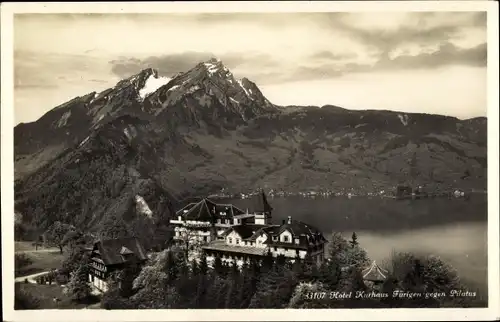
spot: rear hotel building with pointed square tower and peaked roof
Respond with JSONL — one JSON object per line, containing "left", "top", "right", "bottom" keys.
{"left": 170, "top": 192, "right": 272, "bottom": 244}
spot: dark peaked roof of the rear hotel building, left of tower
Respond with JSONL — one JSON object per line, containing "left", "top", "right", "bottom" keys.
{"left": 177, "top": 198, "right": 244, "bottom": 222}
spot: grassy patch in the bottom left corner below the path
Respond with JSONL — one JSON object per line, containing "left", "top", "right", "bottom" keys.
{"left": 16, "top": 283, "right": 100, "bottom": 310}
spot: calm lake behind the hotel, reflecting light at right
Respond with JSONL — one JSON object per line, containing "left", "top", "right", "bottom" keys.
{"left": 224, "top": 194, "right": 488, "bottom": 292}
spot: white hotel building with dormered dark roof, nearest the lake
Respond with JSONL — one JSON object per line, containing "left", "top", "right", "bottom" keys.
{"left": 202, "top": 217, "right": 327, "bottom": 265}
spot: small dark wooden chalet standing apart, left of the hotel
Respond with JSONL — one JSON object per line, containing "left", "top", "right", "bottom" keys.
{"left": 89, "top": 237, "right": 147, "bottom": 292}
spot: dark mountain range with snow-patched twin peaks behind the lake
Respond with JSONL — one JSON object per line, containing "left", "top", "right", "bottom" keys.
{"left": 14, "top": 59, "right": 486, "bottom": 230}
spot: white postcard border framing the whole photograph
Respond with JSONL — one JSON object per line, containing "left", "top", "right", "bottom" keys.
{"left": 1, "top": 1, "right": 500, "bottom": 321}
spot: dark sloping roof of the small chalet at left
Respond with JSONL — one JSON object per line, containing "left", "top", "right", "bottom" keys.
{"left": 93, "top": 237, "right": 147, "bottom": 265}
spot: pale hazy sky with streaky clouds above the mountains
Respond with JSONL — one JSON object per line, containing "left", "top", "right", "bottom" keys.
{"left": 14, "top": 12, "right": 487, "bottom": 123}
